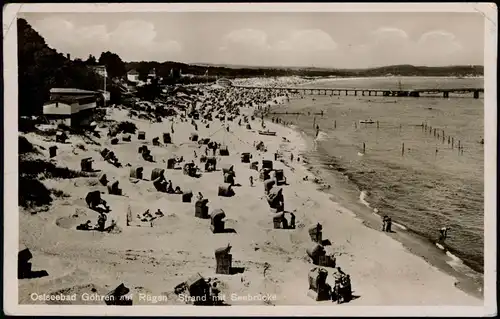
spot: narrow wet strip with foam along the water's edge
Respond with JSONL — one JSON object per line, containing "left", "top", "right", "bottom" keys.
{"left": 266, "top": 99, "right": 484, "bottom": 300}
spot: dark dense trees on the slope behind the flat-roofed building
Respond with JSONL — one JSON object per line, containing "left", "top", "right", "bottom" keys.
{"left": 17, "top": 19, "right": 127, "bottom": 115}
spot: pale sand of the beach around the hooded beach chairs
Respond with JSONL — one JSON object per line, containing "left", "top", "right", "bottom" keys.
{"left": 19, "top": 84, "right": 482, "bottom": 306}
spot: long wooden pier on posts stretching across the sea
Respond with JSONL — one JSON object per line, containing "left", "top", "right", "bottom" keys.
{"left": 234, "top": 85, "right": 484, "bottom": 99}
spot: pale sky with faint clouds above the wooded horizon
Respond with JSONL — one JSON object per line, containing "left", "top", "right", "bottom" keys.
{"left": 19, "top": 12, "right": 484, "bottom": 68}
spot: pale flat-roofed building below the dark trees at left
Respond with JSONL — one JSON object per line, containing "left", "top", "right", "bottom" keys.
{"left": 43, "top": 88, "right": 99, "bottom": 127}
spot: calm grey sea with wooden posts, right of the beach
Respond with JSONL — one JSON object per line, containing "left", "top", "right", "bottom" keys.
{"left": 273, "top": 77, "right": 484, "bottom": 282}
